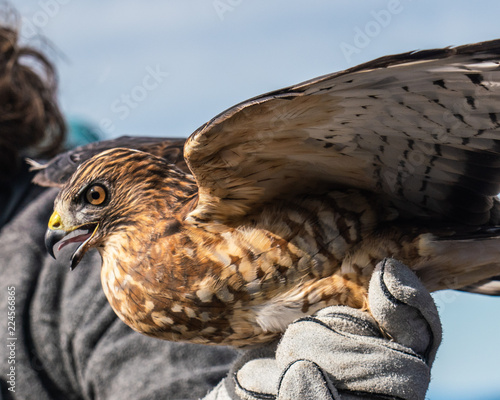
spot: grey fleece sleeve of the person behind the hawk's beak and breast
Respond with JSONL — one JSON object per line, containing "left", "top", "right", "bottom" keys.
{"left": 0, "top": 190, "right": 235, "bottom": 400}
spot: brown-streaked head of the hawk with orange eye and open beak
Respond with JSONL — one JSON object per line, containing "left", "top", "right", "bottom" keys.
{"left": 45, "top": 148, "right": 196, "bottom": 269}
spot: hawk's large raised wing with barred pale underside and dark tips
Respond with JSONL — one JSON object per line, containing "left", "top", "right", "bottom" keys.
{"left": 184, "top": 40, "right": 500, "bottom": 224}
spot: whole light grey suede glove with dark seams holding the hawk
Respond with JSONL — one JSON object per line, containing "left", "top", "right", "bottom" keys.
{"left": 205, "top": 259, "right": 441, "bottom": 400}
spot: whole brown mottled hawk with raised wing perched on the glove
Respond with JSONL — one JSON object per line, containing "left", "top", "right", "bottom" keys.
{"left": 37, "top": 40, "right": 500, "bottom": 346}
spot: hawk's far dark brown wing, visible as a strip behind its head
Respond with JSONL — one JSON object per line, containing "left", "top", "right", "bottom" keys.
{"left": 28, "top": 136, "right": 189, "bottom": 187}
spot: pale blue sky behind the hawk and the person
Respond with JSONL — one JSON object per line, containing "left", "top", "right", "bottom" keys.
{"left": 14, "top": 0, "right": 500, "bottom": 400}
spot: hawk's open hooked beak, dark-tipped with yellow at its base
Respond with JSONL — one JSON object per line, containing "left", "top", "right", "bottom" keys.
{"left": 45, "top": 211, "right": 99, "bottom": 270}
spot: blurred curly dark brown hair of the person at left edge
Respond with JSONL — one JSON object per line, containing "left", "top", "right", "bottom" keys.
{"left": 0, "top": 22, "right": 66, "bottom": 180}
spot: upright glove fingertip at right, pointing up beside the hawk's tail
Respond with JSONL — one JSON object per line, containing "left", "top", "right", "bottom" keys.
{"left": 368, "top": 259, "right": 442, "bottom": 366}
